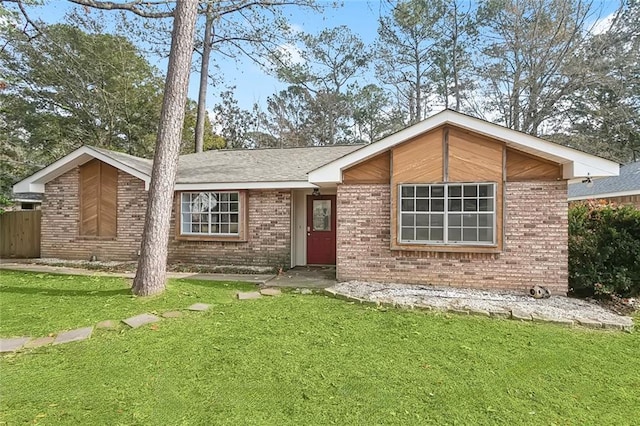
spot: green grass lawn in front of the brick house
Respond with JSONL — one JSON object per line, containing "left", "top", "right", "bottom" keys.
{"left": 0, "top": 273, "right": 640, "bottom": 425}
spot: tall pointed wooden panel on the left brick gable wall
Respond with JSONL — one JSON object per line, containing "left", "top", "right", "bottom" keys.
{"left": 79, "top": 160, "right": 118, "bottom": 238}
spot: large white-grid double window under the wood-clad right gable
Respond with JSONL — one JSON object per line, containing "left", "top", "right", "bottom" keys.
{"left": 398, "top": 183, "right": 496, "bottom": 245}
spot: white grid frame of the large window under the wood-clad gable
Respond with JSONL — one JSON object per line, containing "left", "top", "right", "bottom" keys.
{"left": 397, "top": 182, "right": 497, "bottom": 246}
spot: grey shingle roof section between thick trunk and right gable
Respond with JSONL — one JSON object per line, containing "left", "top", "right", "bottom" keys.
{"left": 176, "top": 145, "right": 362, "bottom": 190}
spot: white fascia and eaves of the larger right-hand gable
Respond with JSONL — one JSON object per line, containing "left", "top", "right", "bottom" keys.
{"left": 309, "top": 110, "right": 619, "bottom": 185}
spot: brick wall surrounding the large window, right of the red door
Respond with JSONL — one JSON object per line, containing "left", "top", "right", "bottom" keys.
{"left": 336, "top": 182, "right": 568, "bottom": 294}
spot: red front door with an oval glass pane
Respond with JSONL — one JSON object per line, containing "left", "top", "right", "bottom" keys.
{"left": 307, "top": 195, "right": 336, "bottom": 265}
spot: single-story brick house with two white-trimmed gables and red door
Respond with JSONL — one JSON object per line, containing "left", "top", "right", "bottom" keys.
{"left": 14, "top": 110, "right": 618, "bottom": 294}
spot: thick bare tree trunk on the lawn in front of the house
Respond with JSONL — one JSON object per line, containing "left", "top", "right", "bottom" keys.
{"left": 133, "top": 0, "right": 198, "bottom": 296}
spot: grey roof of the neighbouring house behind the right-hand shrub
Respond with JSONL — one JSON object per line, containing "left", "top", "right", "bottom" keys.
{"left": 569, "top": 161, "right": 640, "bottom": 201}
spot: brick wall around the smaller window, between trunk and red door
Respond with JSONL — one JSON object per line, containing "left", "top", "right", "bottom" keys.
{"left": 169, "top": 190, "right": 291, "bottom": 268}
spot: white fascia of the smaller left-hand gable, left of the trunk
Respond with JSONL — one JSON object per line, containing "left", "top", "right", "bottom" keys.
{"left": 13, "top": 146, "right": 151, "bottom": 194}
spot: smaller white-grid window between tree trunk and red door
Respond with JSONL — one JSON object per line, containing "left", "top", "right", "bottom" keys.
{"left": 180, "top": 192, "right": 240, "bottom": 236}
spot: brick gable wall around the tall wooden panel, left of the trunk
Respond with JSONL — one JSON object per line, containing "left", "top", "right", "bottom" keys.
{"left": 40, "top": 168, "right": 147, "bottom": 261}
